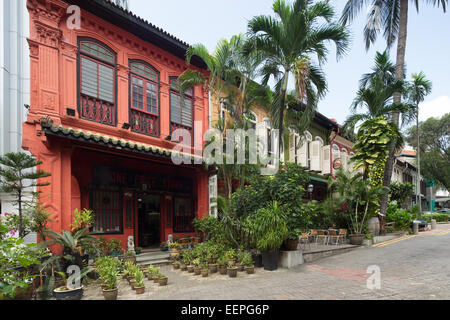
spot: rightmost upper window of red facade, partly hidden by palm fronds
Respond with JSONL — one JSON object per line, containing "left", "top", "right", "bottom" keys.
{"left": 169, "top": 77, "right": 194, "bottom": 145}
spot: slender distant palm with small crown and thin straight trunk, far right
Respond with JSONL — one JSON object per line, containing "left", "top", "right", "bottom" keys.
{"left": 408, "top": 72, "right": 432, "bottom": 215}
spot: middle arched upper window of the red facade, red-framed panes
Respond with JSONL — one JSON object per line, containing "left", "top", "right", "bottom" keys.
{"left": 130, "top": 60, "right": 159, "bottom": 136}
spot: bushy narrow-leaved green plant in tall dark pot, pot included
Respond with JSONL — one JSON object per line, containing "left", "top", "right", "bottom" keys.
{"left": 250, "top": 201, "right": 288, "bottom": 271}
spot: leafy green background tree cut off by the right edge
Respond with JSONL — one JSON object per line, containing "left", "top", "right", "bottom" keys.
{"left": 407, "top": 113, "right": 450, "bottom": 190}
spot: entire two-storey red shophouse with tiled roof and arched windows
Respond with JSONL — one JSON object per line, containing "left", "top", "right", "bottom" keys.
{"left": 23, "top": 0, "right": 214, "bottom": 248}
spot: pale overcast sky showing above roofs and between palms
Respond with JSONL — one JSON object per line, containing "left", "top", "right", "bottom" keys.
{"left": 130, "top": 0, "right": 450, "bottom": 124}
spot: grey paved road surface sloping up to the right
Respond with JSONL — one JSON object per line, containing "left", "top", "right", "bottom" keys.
{"left": 84, "top": 225, "right": 450, "bottom": 300}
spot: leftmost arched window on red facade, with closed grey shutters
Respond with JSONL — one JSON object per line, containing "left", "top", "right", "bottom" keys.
{"left": 78, "top": 38, "right": 116, "bottom": 125}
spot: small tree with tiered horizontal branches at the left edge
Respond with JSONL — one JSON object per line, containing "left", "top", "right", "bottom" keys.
{"left": 0, "top": 152, "right": 51, "bottom": 238}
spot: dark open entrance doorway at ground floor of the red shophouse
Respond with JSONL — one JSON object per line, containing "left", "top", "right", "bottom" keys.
{"left": 138, "top": 194, "right": 161, "bottom": 248}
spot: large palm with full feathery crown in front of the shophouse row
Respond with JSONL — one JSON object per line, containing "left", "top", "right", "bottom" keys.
{"left": 248, "top": 0, "right": 349, "bottom": 159}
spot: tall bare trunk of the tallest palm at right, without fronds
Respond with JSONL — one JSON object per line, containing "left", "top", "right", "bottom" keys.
{"left": 380, "top": 0, "right": 408, "bottom": 231}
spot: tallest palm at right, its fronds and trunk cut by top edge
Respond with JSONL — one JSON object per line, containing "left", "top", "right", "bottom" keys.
{"left": 341, "top": 0, "right": 448, "bottom": 230}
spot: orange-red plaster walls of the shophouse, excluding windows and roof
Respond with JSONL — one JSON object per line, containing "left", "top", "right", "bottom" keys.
{"left": 23, "top": 0, "right": 209, "bottom": 250}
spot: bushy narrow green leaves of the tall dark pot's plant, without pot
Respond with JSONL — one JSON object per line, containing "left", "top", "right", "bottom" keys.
{"left": 249, "top": 201, "right": 289, "bottom": 251}
